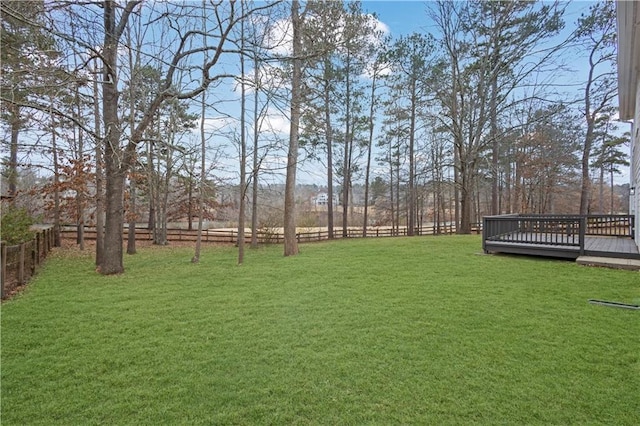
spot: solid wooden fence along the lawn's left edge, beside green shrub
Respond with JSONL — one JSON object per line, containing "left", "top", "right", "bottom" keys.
{"left": 0, "top": 226, "right": 55, "bottom": 299}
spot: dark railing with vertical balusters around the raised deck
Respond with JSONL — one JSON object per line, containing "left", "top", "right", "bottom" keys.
{"left": 482, "top": 214, "right": 634, "bottom": 252}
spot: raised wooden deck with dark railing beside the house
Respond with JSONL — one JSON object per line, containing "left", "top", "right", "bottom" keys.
{"left": 483, "top": 215, "right": 640, "bottom": 259}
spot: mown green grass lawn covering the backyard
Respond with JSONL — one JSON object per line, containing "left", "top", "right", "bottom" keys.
{"left": 1, "top": 236, "right": 640, "bottom": 425}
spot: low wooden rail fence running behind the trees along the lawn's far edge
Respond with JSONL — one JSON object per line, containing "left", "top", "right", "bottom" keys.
{"left": 60, "top": 224, "right": 455, "bottom": 244}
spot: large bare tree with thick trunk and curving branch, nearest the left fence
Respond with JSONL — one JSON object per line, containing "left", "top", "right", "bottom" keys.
{"left": 60, "top": 1, "right": 278, "bottom": 274}
